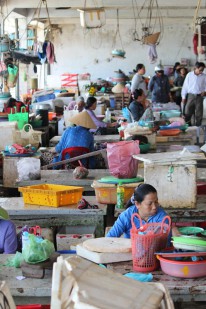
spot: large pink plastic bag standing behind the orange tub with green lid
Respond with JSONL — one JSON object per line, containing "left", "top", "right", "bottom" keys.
{"left": 107, "top": 140, "right": 140, "bottom": 178}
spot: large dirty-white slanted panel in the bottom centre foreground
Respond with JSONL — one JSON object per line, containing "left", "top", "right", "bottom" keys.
{"left": 51, "top": 256, "right": 166, "bottom": 309}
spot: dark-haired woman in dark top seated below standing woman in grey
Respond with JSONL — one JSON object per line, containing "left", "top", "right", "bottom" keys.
{"left": 129, "top": 89, "right": 145, "bottom": 121}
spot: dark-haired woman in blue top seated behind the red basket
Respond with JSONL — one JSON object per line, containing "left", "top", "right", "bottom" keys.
{"left": 107, "top": 184, "right": 180, "bottom": 238}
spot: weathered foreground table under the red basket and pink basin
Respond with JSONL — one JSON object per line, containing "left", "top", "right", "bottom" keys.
{"left": 0, "top": 254, "right": 206, "bottom": 308}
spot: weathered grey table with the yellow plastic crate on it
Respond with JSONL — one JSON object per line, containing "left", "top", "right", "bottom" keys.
{"left": 0, "top": 196, "right": 107, "bottom": 237}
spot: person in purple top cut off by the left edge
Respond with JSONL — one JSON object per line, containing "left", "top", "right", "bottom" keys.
{"left": 0, "top": 207, "right": 17, "bottom": 253}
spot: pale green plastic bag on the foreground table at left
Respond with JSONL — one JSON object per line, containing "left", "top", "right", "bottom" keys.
{"left": 22, "top": 234, "right": 55, "bottom": 264}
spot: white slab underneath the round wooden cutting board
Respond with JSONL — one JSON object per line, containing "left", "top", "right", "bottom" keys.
{"left": 76, "top": 244, "right": 132, "bottom": 264}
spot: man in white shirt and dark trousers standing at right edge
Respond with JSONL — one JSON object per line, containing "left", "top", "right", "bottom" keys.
{"left": 181, "top": 62, "right": 206, "bottom": 127}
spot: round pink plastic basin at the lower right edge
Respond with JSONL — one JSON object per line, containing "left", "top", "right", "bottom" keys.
{"left": 157, "top": 252, "right": 206, "bottom": 278}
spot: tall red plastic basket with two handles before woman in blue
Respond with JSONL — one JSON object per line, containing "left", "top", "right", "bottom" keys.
{"left": 131, "top": 214, "right": 171, "bottom": 272}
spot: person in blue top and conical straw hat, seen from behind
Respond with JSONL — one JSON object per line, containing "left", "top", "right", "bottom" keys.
{"left": 53, "top": 111, "right": 96, "bottom": 168}
